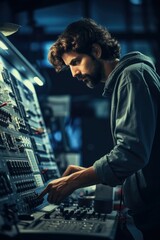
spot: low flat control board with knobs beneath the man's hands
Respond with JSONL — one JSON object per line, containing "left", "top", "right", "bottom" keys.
{"left": 20, "top": 204, "right": 117, "bottom": 240}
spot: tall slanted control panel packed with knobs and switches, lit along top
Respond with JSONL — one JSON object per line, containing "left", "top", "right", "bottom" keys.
{"left": 0, "top": 31, "right": 60, "bottom": 237}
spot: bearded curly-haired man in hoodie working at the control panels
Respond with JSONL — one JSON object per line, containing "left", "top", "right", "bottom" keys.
{"left": 40, "top": 19, "right": 160, "bottom": 239}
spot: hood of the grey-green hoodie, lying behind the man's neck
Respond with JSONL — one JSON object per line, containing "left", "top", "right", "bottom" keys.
{"left": 102, "top": 51, "right": 160, "bottom": 97}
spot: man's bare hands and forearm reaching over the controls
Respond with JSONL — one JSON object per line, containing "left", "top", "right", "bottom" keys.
{"left": 39, "top": 165, "right": 100, "bottom": 204}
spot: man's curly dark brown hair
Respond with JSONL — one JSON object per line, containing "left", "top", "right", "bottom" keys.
{"left": 48, "top": 18, "right": 120, "bottom": 72}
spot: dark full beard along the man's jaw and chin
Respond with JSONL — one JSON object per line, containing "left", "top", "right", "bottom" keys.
{"left": 78, "top": 57, "right": 102, "bottom": 88}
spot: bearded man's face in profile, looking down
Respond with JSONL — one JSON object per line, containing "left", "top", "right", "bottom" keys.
{"left": 62, "top": 52, "right": 102, "bottom": 88}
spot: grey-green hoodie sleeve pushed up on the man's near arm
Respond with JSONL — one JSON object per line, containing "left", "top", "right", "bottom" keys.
{"left": 94, "top": 66, "right": 157, "bottom": 186}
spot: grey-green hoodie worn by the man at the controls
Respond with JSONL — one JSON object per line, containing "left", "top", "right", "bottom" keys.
{"left": 94, "top": 52, "right": 160, "bottom": 229}
